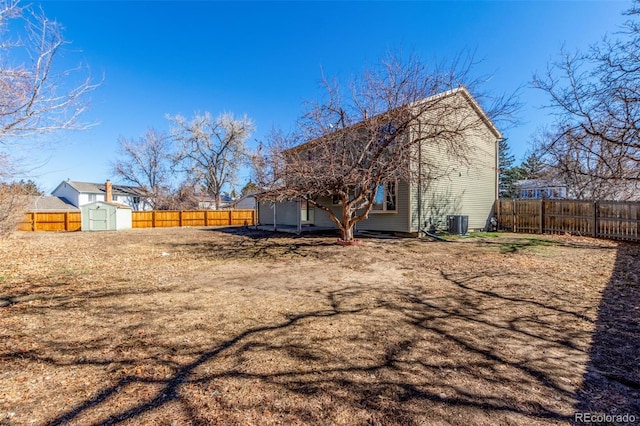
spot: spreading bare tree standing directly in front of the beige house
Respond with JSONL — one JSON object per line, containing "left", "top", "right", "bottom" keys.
{"left": 253, "top": 51, "right": 516, "bottom": 241}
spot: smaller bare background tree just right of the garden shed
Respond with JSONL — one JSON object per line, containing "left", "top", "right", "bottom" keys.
{"left": 113, "top": 129, "right": 172, "bottom": 209}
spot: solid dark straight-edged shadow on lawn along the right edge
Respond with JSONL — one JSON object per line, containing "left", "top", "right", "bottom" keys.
{"left": 575, "top": 243, "right": 640, "bottom": 424}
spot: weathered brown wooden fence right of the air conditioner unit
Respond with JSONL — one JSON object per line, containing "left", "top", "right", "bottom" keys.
{"left": 496, "top": 199, "right": 640, "bottom": 241}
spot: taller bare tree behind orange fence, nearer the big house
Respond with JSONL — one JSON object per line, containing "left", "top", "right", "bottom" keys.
{"left": 167, "top": 112, "right": 254, "bottom": 208}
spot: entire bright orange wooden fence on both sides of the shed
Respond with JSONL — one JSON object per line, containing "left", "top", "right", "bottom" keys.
{"left": 18, "top": 210, "right": 255, "bottom": 231}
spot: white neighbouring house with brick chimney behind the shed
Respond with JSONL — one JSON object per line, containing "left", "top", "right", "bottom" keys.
{"left": 51, "top": 179, "right": 152, "bottom": 210}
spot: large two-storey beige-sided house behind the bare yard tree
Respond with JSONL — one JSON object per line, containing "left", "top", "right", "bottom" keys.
{"left": 258, "top": 88, "right": 502, "bottom": 235}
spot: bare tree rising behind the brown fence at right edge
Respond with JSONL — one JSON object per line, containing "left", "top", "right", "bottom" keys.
{"left": 534, "top": 1, "right": 640, "bottom": 199}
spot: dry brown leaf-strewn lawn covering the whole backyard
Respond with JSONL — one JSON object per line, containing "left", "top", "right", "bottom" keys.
{"left": 0, "top": 228, "right": 640, "bottom": 425}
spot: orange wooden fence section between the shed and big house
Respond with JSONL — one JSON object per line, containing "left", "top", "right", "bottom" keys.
{"left": 131, "top": 210, "right": 255, "bottom": 228}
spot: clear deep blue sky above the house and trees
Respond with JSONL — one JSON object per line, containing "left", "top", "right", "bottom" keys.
{"left": 23, "top": 0, "right": 631, "bottom": 193}
